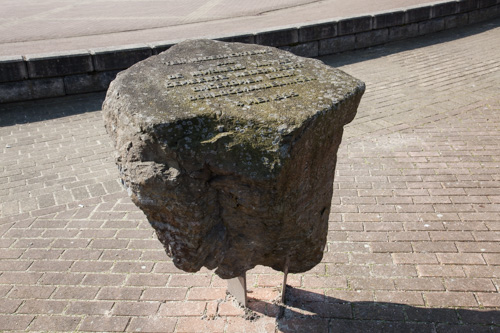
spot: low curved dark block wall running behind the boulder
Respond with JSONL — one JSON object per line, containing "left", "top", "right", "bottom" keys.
{"left": 0, "top": 0, "right": 500, "bottom": 103}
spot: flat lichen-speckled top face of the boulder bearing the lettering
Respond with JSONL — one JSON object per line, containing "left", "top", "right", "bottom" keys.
{"left": 108, "top": 40, "right": 363, "bottom": 127}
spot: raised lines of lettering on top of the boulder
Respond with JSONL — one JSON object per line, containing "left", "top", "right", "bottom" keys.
{"left": 165, "top": 50, "right": 315, "bottom": 107}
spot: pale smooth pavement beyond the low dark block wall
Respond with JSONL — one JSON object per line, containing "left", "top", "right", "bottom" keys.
{"left": 0, "top": 0, "right": 443, "bottom": 56}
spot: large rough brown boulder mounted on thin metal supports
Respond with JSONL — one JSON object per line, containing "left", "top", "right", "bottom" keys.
{"left": 103, "top": 40, "right": 364, "bottom": 278}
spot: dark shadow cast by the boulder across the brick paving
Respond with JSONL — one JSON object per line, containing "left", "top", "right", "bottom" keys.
{"left": 249, "top": 286, "right": 500, "bottom": 333}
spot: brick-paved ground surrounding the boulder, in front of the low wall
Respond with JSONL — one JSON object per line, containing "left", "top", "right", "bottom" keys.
{"left": 0, "top": 20, "right": 500, "bottom": 332}
